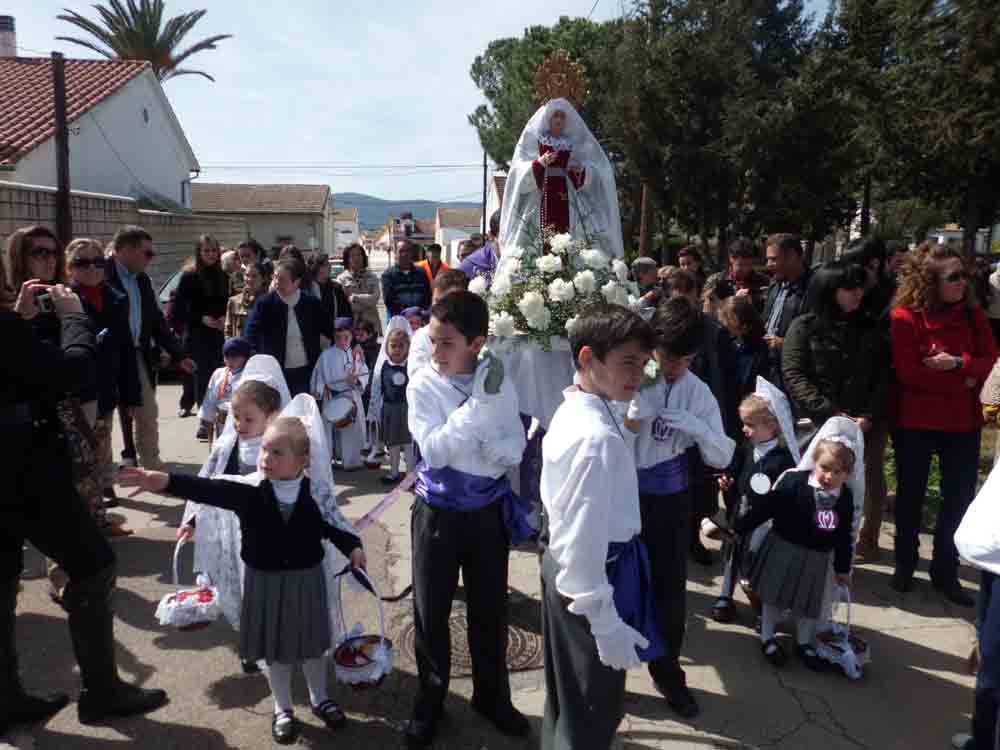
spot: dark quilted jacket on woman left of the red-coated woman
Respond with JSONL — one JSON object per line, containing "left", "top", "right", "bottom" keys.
{"left": 781, "top": 313, "right": 889, "bottom": 426}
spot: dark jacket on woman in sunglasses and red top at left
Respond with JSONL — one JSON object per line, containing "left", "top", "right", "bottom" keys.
{"left": 77, "top": 284, "right": 142, "bottom": 417}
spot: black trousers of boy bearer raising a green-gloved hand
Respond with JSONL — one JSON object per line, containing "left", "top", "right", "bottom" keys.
{"left": 411, "top": 498, "right": 510, "bottom": 724}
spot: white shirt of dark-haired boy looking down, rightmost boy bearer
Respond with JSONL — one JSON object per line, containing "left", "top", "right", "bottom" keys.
{"left": 628, "top": 371, "right": 736, "bottom": 469}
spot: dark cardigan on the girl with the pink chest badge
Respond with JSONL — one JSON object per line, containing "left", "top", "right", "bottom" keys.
{"left": 735, "top": 471, "right": 854, "bottom": 573}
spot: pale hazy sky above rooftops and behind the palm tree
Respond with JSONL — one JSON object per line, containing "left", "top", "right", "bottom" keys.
{"left": 11, "top": 0, "right": 827, "bottom": 200}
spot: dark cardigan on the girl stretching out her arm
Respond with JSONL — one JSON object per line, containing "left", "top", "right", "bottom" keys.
{"left": 167, "top": 474, "right": 361, "bottom": 571}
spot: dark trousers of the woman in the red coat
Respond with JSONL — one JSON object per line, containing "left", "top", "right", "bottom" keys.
{"left": 892, "top": 429, "right": 981, "bottom": 584}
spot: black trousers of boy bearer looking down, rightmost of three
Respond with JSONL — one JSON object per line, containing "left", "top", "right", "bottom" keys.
{"left": 639, "top": 491, "right": 691, "bottom": 687}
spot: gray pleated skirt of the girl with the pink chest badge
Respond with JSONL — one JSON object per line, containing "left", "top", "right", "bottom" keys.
{"left": 750, "top": 530, "right": 832, "bottom": 619}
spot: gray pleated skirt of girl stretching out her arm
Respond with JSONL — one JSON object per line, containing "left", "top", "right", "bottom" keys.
{"left": 240, "top": 564, "right": 330, "bottom": 664}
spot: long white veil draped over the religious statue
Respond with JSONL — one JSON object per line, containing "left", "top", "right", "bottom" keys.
{"left": 499, "top": 99, "right": 625, "bottom": 258}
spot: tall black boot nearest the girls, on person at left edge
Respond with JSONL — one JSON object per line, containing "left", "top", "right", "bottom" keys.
{"left": 63, "top": 565, "right": 167, "bottom": 724}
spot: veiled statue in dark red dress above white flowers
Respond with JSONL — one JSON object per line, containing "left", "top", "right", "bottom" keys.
{"left": 500, "top": 99, "right": 624, "bottom": 258}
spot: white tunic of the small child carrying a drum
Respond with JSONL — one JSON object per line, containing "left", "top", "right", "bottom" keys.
{"left": 311, "top": 346, "right": 368, "bottom": 469}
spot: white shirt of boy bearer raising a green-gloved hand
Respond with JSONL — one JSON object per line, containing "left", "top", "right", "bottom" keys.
{"left": 407, "top": 361, "right": 526, "bottom": 479}
